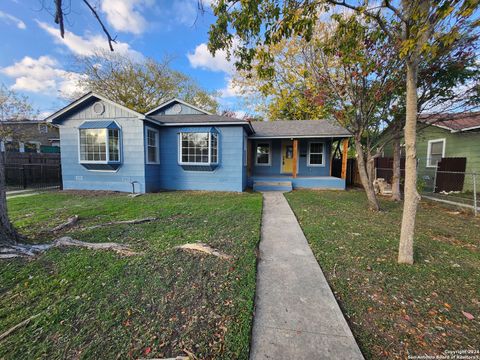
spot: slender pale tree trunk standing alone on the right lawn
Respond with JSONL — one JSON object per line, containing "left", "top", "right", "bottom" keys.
{"left": 398, "top": 60, "right": 420, "bottom": 264}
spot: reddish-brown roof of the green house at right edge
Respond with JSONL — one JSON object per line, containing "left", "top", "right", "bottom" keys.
{"left": 418, "top": 111, "right": 480, "bottom": 132}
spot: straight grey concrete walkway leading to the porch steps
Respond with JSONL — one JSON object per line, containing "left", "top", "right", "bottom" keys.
{"left": 250, "top": 192, "right": 363, "bottom": 360}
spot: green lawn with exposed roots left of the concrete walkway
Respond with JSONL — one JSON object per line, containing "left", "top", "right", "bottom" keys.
{"left": 0, "top": 192, "right": 262, "bottom": 359}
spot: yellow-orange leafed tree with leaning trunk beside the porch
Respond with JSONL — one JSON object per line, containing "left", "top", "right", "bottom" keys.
{"left": 234, "top": 16, "right": 401, "bottom": 210}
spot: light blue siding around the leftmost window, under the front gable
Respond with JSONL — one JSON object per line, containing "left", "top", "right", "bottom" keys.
{"left": 59, "top": 100, "right": 146, "bottom": 192}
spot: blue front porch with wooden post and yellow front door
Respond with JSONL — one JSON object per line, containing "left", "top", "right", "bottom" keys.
{"left": 247, "top": 136, "right": 348, "bottom": 191}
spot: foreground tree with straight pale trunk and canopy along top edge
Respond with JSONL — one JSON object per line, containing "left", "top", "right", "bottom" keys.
{"left": 209, "top": 0, "right": 479, "bottom": 264}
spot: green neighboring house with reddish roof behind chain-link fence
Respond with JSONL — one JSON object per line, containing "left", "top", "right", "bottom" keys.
{"left": 384, "top": 112, "right": 480, "bottom": 190}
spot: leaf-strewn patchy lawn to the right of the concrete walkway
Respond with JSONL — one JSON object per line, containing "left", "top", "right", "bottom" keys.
{"left": 286, "top": 190, "right": 480, "bottom": 359}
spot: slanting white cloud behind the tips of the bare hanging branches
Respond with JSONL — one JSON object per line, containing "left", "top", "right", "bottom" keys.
{"left": 37, "top": 21, "right": 142, "bottom": 58}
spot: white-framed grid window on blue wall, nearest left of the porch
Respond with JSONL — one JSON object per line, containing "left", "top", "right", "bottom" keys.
{"left": 180, "top": 132, "right": 218, "bottom": 165}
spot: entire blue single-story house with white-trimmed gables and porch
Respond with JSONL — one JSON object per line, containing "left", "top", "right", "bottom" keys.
{"left": 46, "top": 93, "right": 351, "bottom": 193}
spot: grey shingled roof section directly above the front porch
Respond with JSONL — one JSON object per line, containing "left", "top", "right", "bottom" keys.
{"left": 250, "top": 120, "right": 352, "bottom": 138}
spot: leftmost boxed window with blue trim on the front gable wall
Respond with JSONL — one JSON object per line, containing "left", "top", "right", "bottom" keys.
{"left": 79, "top": 121, "right": 121, "bottom": 170}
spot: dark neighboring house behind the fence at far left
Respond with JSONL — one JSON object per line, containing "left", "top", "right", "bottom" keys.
{"left": 0, "top": 120, "right": 60, "bottom": 153}
